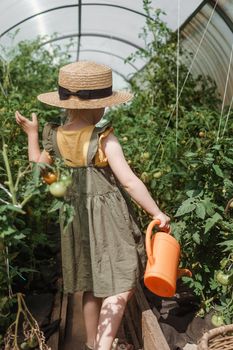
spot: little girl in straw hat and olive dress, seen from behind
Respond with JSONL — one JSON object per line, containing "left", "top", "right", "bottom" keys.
{"left": 16, "top": 61, "right": 169, "bottom": 350}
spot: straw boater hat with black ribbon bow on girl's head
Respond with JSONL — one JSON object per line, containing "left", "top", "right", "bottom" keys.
{"left": 37, "top": 61, "right": 133, "bottom": 109}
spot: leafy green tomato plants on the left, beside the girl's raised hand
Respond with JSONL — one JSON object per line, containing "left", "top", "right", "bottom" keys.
{"left": 0, "top": 38, "right": 72, "bottom": 342}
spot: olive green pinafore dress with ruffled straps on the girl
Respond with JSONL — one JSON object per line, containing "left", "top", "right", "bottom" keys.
{"left": 43, "top": 124, "right": 145, "bottom": 297}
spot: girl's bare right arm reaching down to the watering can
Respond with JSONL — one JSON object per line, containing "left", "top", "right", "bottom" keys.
{"left": 103, "top": 133, "right": 170, "bottom": 227}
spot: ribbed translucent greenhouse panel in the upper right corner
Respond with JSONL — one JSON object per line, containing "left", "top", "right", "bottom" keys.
{"left": 182, "top": 1, "right": 233, "bottom": 104}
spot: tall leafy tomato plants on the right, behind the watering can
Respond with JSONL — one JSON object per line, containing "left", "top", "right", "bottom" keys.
{"left": 108, "top": 2, "right": 233, "bottom": 323}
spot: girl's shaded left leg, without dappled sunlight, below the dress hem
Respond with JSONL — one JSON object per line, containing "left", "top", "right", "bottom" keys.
{"left": 83, "top": 292, "right": 102, "bottom": 348}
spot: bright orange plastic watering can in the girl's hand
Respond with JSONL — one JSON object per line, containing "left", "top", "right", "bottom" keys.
{"left": 144, "top": 220, "right": 192, "bottom": 297}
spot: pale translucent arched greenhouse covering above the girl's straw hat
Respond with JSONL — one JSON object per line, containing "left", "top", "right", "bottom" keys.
{"left": 0, "top": 0, "right": 202, "bottom": 87}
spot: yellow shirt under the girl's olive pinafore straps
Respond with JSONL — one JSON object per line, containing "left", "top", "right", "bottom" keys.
{"left": 57, "top": 125, "right": 113, "bottom": 167}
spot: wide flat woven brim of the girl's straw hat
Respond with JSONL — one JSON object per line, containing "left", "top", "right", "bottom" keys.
{"left": 37, "top": 91, "right": 133, "bottom": 109}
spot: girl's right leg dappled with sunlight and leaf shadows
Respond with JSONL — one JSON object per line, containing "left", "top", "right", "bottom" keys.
{"left": 95, "top": 290, "right": 133, "bottom": 350}
